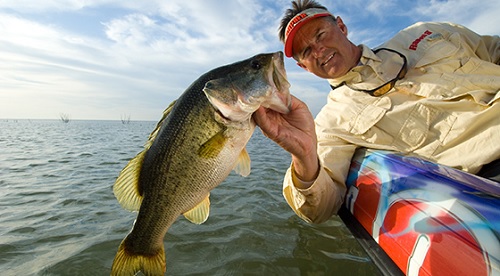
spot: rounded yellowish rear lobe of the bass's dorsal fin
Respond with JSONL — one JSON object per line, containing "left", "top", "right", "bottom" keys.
{"left": 113, "top": 150, "right": 146, "bottom": 211}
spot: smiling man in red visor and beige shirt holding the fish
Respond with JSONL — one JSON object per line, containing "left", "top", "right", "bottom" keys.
{"left": 254, "top": 0, "right": 500, "bottom": 223}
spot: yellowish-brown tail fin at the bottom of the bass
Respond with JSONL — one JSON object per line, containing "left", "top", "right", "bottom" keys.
{"left": 111, "top": 240, "right": 166, "bottom": 276}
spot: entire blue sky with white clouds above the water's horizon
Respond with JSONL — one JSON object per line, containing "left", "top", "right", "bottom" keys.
{"left": 0, "top": 0, "right": 500, "bottom": 121}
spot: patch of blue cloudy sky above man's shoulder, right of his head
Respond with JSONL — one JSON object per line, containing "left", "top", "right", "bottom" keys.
{"left": 326, "top": 0, "right": 500, "bottom": 47}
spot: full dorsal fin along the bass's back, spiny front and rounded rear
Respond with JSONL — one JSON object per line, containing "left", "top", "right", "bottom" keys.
{"left": 113, "top": 101, "right": 176, "bottom": 211}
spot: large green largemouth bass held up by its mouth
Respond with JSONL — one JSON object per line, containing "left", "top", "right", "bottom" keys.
{"left": 111, "top": 52, "right": 291, "bottom": 276}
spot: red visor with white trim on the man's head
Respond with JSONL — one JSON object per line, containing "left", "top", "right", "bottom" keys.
{"left": 285, "top": 8, "right": 333, "bottom": 57}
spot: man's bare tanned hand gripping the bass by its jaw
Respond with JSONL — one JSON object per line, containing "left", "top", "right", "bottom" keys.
{"left": 253, "top": 96, "right": 319, "bottom": 181}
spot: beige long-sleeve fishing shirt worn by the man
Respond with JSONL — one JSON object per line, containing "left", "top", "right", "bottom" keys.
{"left": 283, "top": 23, "right": 500, "bottom": 223}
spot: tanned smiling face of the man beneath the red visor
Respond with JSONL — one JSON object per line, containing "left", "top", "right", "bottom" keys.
{"left": 293, "top": 17, "right": 360, "bottom": 79}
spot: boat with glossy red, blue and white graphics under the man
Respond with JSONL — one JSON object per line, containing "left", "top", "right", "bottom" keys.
{"left": 339, "top": 149, "right": 500, "bottom": 276}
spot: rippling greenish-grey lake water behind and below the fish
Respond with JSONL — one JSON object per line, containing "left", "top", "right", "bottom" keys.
{"left": 0, "top": 120, "right": 378, "bottom": 275}
